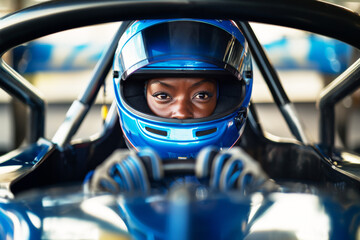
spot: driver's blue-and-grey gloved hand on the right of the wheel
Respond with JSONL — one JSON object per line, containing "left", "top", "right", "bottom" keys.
{"left": 195, "top": 147, "right": 268, "bottom": 194}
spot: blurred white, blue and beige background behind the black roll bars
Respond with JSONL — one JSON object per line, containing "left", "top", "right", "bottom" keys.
{"left": 0, "top": 0, "right": 360, "bottom": 152}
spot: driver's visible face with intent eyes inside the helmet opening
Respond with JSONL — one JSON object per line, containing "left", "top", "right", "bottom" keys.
{"left": 146, "top": 78, "right": 217, "bottom": 119}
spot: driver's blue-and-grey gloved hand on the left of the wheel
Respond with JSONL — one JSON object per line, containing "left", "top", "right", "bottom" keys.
{"left": 85, "top": 149, "right": 163, "bottom": 193}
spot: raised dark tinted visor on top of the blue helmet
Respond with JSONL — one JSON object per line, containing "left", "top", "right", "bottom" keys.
{"left": 119, "top": 21, "right": 244, "bottom": 79}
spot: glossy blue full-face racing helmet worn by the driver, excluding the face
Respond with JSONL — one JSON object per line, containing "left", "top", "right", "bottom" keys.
{"left": 113, "top": 19, "right": 253, "bottom": 160}
